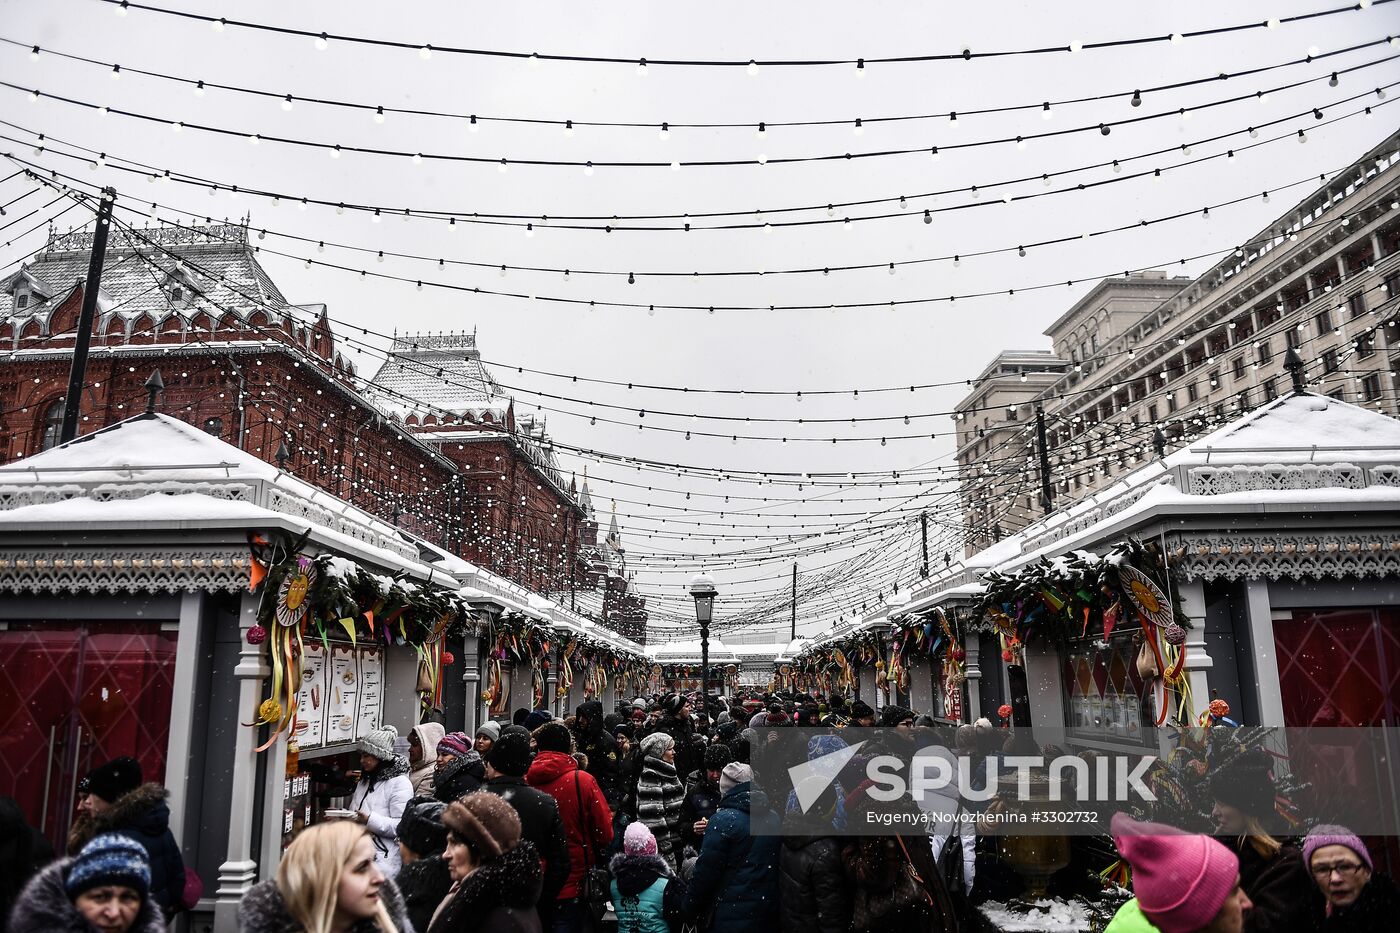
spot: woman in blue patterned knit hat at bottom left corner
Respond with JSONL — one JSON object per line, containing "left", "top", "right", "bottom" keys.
{"left": 6, "top": 834, "right": 165, "bottom": 933}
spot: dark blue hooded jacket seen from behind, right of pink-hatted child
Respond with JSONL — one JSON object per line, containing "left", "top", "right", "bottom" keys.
{"left": 686, "top": 782, "right": 780, "bottom": 933}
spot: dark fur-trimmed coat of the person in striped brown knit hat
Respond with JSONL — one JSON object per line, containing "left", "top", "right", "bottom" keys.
{"left": 426, "top": 839, "right": 540, "bottom": 933}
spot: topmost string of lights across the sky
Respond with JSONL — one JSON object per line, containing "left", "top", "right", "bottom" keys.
{"left": 101, "top": 0, "right": 1392, "bottom": 69}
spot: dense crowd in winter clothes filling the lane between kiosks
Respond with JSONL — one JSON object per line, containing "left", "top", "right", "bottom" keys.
{"left": 0, "top": 693, "right": 1400, "bottom": 933}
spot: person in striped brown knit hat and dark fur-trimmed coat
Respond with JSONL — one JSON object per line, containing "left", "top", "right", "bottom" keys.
{"left": 427, "top": 790, "right": 543, "bottom": 933}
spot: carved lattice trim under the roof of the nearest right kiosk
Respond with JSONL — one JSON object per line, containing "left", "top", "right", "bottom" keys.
{"left": 1172, "top": 531, "right": 1400, "bottom": 580}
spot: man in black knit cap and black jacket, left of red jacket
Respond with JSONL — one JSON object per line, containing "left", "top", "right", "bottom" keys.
{"left": 482, "top": 726, "right": 570, "bottom": 930}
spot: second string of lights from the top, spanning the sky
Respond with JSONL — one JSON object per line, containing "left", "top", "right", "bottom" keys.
{"left": 8, "top": 35, "right": 1392, "bottom": 141}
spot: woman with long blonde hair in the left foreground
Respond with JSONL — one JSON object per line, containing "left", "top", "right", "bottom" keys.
{"left": 238, "top": 821, "right": 410, "bottom": 933}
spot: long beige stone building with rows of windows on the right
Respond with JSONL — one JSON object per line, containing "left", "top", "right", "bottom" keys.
{"left": 955, "top": 133, "right": 1400, "bottom": 553}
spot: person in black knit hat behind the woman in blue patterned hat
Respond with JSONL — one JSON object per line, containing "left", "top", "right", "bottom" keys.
{"left": 67, "top": 758, "right": 185, "bottom": 919}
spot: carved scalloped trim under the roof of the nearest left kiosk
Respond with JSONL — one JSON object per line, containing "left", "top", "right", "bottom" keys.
{"left": 0, "top": 548, "right": 248, "bottom": 593}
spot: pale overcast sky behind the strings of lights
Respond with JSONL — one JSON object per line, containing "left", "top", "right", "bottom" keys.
{"left": 8, "top": 0, "right": 1400, "bottom": 632}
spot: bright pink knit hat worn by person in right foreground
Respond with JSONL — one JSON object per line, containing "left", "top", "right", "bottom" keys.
{"left": 1112, "top": 813, "right": 1239, "bottom": 933}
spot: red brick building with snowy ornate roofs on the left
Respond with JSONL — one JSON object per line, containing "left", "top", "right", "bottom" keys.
{"left": 0, "top": 218, "right": 645, "bottom": 624}
